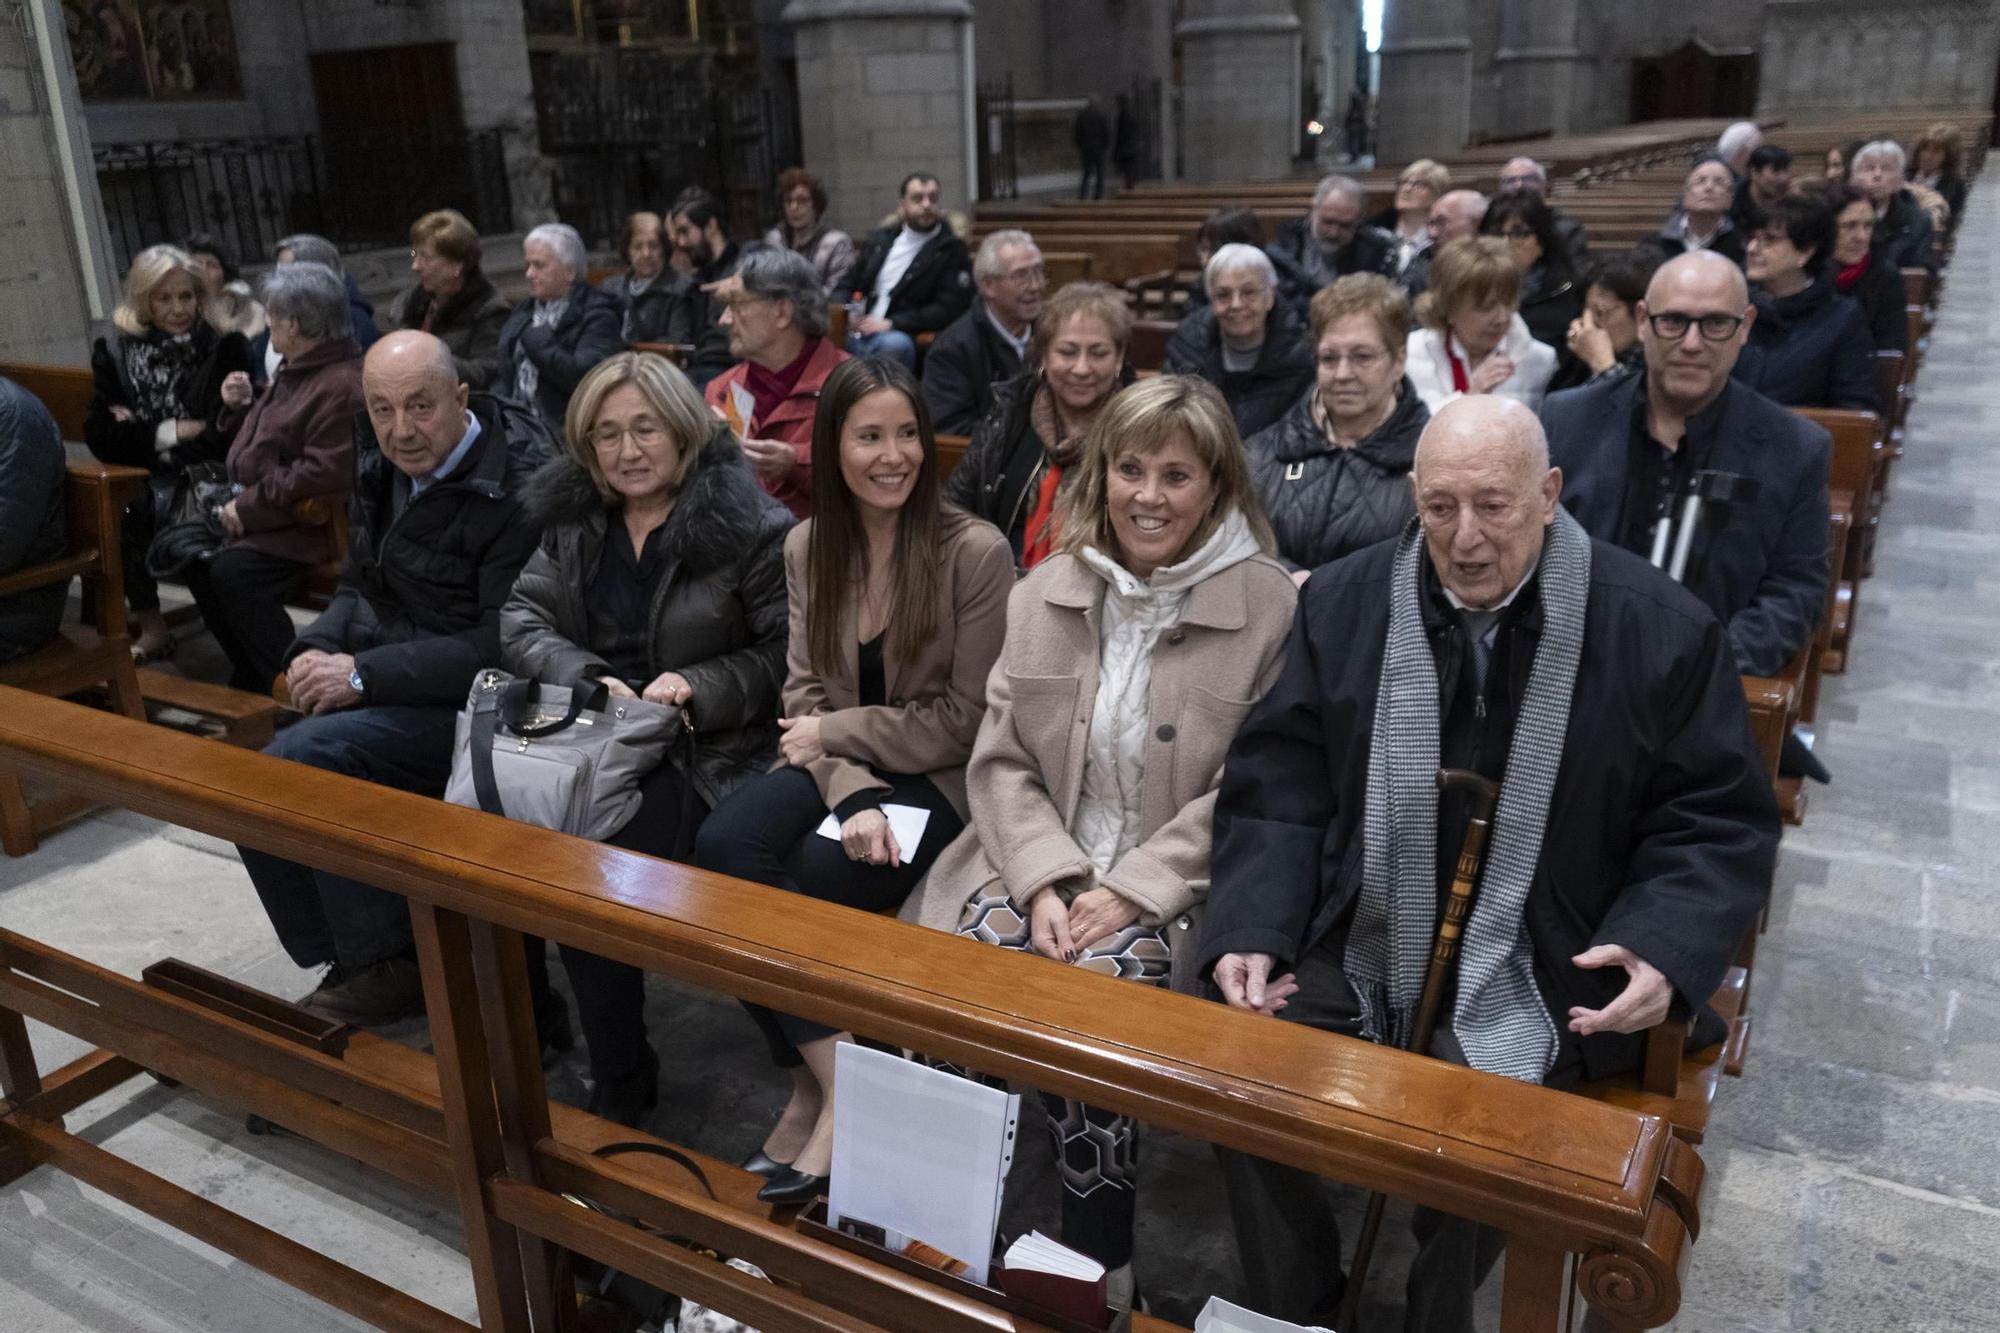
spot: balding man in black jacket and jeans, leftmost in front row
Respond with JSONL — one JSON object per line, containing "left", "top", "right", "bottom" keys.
{"left": 238, "top": 332, "right": 554, "bottom": 1025}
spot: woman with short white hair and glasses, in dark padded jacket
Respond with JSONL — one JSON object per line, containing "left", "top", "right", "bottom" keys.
{"left": 1164, "top": 244, "right": 1312, "bottom": 438}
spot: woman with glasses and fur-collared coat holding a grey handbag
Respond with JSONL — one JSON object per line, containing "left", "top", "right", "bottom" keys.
{"left": 500, "top": 352, "right": 792, "bottom": 1127}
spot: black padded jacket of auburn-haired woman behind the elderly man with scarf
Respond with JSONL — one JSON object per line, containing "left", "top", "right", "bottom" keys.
{"left": 1248, "top": 380, "right": 1430, "bottom": 570}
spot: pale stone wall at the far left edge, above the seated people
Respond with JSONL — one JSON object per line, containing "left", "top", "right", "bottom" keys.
{"left": 0, "top": 13, "right": 90, "bottom": 366}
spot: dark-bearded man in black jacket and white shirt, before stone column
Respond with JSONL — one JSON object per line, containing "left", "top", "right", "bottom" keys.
{"left": 848, "top": 172, "right": 972, "bottom": 368}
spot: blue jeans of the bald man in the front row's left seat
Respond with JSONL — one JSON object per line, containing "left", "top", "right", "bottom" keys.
{"left": 236, "top": 705, "right": 458, "bottom": 971}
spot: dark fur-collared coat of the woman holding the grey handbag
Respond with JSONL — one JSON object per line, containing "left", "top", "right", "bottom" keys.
{"left": 500, "top": 430, "right": 792, "bottom": 807}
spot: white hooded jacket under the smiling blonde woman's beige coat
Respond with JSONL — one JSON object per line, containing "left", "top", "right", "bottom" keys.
{"left": 1070, "top": 510, "right": 1258, "bottom": 875}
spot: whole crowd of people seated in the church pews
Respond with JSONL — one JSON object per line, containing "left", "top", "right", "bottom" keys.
{"left": 0, "top": 119, "right": 1964, "bottom": 1329}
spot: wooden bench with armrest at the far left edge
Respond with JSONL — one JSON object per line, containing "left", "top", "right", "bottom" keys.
{"left": 0, "top": 462, "right": 146, "bottom": 857}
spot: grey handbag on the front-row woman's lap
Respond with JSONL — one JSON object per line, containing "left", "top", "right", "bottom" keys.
{"left": 444, "top": 671, "right": 692, "bottom": 843}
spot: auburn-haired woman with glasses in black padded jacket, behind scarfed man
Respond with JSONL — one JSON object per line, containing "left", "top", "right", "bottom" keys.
{"left": 1248, "top": 272, "right": 1430, "bottom": 580}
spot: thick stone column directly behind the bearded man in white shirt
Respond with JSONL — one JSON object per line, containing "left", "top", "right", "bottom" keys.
{"left": 784, "top": 0, "right": 978, "bottom": 240}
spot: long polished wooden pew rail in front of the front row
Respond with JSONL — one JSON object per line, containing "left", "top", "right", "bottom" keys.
{"left": 0, "top": 693, "right": 1702, "bottom": 1333}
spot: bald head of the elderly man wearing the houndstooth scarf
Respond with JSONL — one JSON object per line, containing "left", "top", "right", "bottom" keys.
{"left": 1410, "top": 394, "right": 1562, "bottom": 608}
